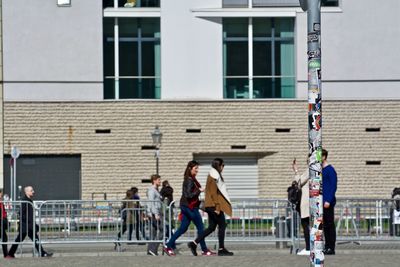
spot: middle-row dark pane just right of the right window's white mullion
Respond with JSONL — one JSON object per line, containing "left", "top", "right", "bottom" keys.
{"left": 253, "top": 42, "right": 272, "bottom": 76}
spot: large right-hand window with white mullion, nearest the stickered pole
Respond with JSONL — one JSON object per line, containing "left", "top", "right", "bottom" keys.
{"left": 223, "top": 18, "right": 295, "bottom": 99}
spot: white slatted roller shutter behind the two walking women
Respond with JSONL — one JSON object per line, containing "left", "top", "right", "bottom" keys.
{"left": 194, "top": 155, "right": 258, "bottom": 199}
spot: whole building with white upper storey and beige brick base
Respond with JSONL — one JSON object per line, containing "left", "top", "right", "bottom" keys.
{"left": 3, "top": 0, "right": 400, "bottom": 201}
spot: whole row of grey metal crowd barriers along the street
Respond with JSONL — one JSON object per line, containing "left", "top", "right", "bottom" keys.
{"left": 0, "top": 199, "right": 400, "bottom": 255}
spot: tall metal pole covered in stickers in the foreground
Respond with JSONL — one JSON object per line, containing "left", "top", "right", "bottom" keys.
{"left": 307, "top": 0, "right": 325, "bottom": 266}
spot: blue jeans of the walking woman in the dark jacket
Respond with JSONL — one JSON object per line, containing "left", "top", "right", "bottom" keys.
{"left": 166, "top": 206, "right": 207, "bottom": 251}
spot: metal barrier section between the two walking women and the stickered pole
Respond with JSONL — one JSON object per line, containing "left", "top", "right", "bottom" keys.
{"left": 168, "top": 199, "right": 299, "bottom": 248}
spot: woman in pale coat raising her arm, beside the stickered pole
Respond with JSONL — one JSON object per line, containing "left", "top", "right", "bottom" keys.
{"left": 292, "top": 159, "right": 310, "bottom": 256}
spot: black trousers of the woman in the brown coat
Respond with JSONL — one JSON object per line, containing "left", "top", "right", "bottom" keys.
{"left": 194, "top": 208, "right": 226, "bottom": 248}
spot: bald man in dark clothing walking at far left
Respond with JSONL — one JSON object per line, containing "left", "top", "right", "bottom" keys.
{"left": 8, "top": 186, "right": 53, "bottom": 258}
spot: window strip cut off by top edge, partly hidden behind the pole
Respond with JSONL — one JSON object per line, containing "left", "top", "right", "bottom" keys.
{"left": 222, "top": 0, "right": 339, "bottom": 8}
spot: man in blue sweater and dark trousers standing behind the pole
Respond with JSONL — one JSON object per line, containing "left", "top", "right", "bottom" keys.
{"left": 322, "top": 149, "right": 337, "bottom": 255}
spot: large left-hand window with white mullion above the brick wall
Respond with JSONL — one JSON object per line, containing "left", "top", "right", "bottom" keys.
{"left": 104, "top": 18, "right": 161, "bottom": 99}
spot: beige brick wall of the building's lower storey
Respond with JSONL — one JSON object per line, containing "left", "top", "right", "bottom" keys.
{"left": 4, "top": 100, "right": 400, "bottom": 199}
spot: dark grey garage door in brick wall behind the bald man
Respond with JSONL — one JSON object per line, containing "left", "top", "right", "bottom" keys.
{"left": 4, "top": 155, "right": 81, "bottom": 200}
